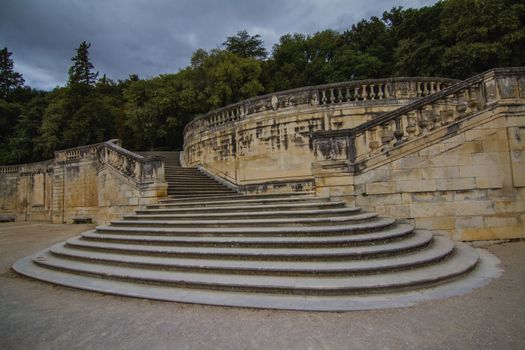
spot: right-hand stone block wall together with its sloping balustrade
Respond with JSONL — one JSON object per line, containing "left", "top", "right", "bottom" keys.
{"left": 314, "top": 69, "right": 525, "bottom": 241}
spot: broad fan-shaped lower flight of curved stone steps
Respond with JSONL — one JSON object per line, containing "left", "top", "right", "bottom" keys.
{"left": 13, "top": 182, "right": 479, "bottom": 310}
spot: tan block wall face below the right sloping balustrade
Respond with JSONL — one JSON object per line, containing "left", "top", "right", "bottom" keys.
{"left": 348, "top": 111, "right": 525, "bottom": 240}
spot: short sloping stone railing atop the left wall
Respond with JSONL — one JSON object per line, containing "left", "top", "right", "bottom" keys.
{"left": 97, "top": 140, "right": 164, "bottom": 183}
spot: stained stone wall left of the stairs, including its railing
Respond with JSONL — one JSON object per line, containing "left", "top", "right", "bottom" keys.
{"left": 0, "top": 140, "right": 167, "bottom": 224}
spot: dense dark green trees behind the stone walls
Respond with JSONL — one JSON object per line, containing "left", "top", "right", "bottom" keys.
{"left": 0, "top": 0, "right": 525, "bottom": 163}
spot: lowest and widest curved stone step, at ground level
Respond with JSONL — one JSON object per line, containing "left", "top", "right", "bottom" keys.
{"left": 13, "top": 243, "right": 501, "bottom": 312}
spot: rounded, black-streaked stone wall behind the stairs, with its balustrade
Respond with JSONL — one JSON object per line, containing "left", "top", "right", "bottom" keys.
{"left": 184, "top": 78, "right": 452, "bottom": 193}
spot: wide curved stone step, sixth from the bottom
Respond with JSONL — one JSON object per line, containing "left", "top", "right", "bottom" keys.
{"left": 96, "top": 218, "right": 395, "bottom": 236}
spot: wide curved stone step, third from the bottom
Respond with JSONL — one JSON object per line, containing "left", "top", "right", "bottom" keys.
{"left": 50, "top": 237, "right": 454, "bottom": 276}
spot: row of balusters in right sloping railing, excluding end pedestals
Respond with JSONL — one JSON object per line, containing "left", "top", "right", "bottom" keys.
{"left": 355, "top": 85, "right": 482, "bottom": 160}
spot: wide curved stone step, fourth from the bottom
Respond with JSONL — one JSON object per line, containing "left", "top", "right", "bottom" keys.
{"left": 62, "top": 231, "right": 432, "bottom": 260}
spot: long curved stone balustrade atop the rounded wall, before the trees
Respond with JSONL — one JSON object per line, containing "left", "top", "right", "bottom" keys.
{"left": 184, "top": 77, "right": 457, "bottom": 141}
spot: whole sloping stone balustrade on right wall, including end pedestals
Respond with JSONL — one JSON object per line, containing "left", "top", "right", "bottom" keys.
{"left": 312, "top": 67, "right": 525, "bottom": 170}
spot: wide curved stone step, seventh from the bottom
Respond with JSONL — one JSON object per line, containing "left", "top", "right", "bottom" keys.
{"left": 111, "top": 213, "right": 377, "bottom": 228}
